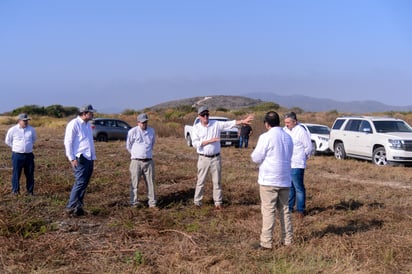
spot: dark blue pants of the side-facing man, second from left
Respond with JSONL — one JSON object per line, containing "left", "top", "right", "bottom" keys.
{"left": 67, "top": 156, "right": 94, "bottom": 209}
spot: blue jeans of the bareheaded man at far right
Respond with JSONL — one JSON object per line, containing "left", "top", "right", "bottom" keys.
{"left": 289, "top": 168, "right": 306, "bottom": 213}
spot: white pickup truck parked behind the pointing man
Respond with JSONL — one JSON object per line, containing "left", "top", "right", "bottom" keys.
{"left": 185, "top": 116, "right": 239, "bottom": 147}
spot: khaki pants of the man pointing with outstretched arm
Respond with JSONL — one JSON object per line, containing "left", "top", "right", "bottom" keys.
{"left": 194, "top": 156, "right": 222, "bottom": 206}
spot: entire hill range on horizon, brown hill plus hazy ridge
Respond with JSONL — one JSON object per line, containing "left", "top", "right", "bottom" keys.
{"left": 151, "top": 93, "right": 412, "bottom": 114}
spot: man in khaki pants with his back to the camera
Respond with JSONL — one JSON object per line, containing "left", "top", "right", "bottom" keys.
{"left": 251, "top": 111, "right": 293, "bottom": 249}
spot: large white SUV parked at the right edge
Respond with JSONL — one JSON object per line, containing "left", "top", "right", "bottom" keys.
{"left": 329, "top": 116, "right": 412, "bottom": 166}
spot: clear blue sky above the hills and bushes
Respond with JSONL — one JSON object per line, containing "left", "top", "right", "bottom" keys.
{"left": 0, "top": 0, "right": 412, "bottom": 113}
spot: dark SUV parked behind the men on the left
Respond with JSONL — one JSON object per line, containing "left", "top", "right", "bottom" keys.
{"left": 91, "top": 118, "right": 132, "bottom": 142}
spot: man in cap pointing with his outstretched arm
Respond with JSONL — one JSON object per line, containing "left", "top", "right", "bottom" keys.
{"left": 192, "top": 106, "right": 253, "bottom": 210}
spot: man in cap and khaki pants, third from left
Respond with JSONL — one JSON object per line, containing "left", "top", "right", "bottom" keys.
{"left": 126, "top": 113, "right": 158, "bottom": 209}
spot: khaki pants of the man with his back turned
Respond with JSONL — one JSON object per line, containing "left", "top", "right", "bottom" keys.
{"left": 259, "top": 185, "right": 293, "bottom": 248}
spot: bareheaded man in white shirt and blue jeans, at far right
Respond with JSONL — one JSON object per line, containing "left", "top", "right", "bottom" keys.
{"left": 284, "top": 112, "right": 312, "bottom": 219}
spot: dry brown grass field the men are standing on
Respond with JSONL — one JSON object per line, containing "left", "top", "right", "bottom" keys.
{"left": 0, "top": 113, "right": 412, "bottom": 273}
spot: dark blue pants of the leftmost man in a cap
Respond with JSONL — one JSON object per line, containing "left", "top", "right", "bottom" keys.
{"left": 11, "top": 152, "right": 34, "bottom": 194}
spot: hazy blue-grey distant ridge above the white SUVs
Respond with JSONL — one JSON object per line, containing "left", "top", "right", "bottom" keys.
{"left": 245, "top": 93, "right": 412, "bottom": 113}
